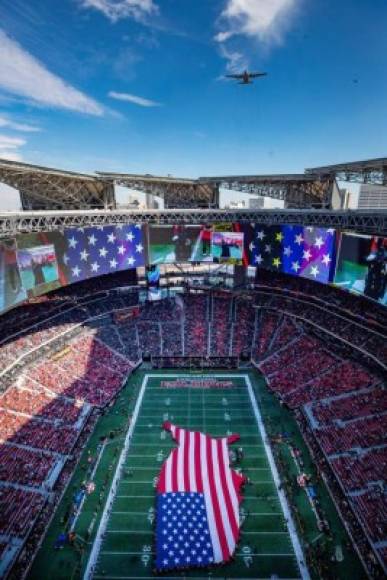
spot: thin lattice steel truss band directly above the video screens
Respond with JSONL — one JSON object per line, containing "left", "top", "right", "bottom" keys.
{"left": 0, "top": 209, "right": 387, "bottom": 238}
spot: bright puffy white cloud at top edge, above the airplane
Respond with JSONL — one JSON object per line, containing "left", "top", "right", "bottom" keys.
{"left": 215, "top": 0, "right": 299, "bottom": 42}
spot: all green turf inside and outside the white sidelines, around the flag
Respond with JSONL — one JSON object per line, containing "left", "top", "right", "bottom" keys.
{"left": 29, "top": 371, "right": 363, "bottom": 580}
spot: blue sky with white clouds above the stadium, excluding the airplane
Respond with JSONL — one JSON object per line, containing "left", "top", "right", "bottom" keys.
{"left": 0, "top": 0, "right": 387, "bottom": 184}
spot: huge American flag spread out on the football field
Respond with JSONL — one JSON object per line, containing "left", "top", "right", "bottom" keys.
{"left": 156, "top": 422, "right": 245, "bottom": 571}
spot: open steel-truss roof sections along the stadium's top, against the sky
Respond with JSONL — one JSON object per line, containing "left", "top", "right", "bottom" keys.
{"left": 0, "top": 158, "right": 387, "bottom": 211}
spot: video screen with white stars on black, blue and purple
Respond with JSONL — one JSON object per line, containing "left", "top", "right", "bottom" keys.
{"left": 241, "top": 224, "right": 336, "bottom": 283}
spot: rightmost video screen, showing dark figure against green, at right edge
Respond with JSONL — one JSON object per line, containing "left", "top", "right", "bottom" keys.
{"left": 334, "top": 234, "right": 387, "bottom": 305}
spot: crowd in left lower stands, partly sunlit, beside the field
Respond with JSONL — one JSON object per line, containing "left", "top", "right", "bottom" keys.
{"left": 0, "top": 297, "right": 137, "bottom": 576}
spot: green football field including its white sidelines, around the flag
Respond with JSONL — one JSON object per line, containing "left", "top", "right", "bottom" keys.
{"left": 85, "top": 373, "right": 308, "bottom": 580}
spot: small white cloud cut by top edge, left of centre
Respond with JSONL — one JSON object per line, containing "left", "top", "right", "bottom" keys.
{"left": 80, "top": 0, "right": 158, "bottom": 22}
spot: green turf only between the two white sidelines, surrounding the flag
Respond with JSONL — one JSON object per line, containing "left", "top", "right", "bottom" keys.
{"left": 91, "top": 378, "right": 298, "bottom": 578}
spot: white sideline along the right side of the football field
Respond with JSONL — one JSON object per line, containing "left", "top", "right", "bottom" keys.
{"left": 245, "top": 375, "right": 310, "bottom": 580}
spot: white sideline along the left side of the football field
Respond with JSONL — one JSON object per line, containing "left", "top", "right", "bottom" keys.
{"left": 83, "top": 375, "right": 149, "bottom": 580}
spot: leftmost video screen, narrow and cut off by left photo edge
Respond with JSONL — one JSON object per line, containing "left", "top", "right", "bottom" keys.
{"left": 0, "top": 239, "right": 27, "bottom": 312}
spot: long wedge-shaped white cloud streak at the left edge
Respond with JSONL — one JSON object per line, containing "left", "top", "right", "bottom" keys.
{"left": 0, "top": 30, "right": 104, "bottom": 116}
